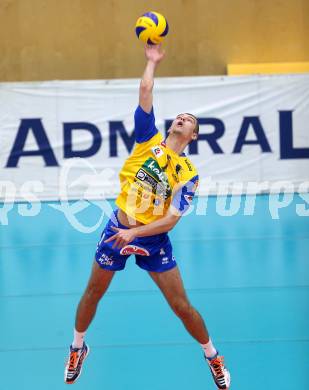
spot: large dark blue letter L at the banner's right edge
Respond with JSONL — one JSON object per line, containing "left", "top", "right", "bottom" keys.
{"left": 279, "top": 111, "right": 309, "bottom": 160}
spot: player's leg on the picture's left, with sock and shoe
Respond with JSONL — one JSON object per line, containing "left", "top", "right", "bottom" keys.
{"left": 64, "top": 261, "right": 115, "bottom": 384}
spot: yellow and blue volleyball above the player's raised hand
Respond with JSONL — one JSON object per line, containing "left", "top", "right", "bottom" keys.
{"left": 135, "top": 11, "right": 168, "bottom": 45}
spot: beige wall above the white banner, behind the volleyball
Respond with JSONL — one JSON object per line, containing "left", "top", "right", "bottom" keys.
{"left": 0, "top": 0, "right": 309, "bottom": 81}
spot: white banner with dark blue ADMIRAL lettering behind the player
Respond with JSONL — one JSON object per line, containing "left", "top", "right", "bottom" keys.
{"left": 0, "top": 75, "right": 309, "bottom": 201}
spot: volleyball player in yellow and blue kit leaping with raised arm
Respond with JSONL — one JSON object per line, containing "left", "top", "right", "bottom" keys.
{"left": 65, "top": 45, "right": 230, "bottom": 389}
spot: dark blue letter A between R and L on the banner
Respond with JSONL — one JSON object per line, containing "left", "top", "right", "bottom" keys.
{"left": 233, "top": 116, "right": 271, "bottom": 153}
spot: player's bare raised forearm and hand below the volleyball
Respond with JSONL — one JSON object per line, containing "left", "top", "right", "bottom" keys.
{"left": 139, "top": 45, "right": 165, "bottom": 113}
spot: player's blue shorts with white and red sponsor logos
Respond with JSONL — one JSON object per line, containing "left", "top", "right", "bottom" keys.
{"left": 95, "top": 210, "right": 177, "bottom": 272}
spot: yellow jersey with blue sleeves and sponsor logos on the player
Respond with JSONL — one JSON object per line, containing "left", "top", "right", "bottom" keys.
{"left": 116, "top": 106, "right": 198, "bottom": 224}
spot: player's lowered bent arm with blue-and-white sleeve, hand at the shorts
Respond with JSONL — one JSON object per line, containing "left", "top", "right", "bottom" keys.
{"left": 105, "top": 175, "right": 198, "bottom": 248}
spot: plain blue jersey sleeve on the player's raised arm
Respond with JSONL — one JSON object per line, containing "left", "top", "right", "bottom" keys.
{"left": 134, "top": 106, "right": 158, "bottom": 143}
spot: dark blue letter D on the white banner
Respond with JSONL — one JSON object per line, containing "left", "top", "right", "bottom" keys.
{"left": 63, "top": 122, "right": 102, "bottom": 158}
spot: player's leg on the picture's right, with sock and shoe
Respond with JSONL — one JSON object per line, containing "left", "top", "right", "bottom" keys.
{"left": 149, "top": 267, "right": 230, "bottom": 389}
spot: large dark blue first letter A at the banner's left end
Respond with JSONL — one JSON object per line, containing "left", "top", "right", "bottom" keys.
{"left": 6, "top": 118, "right": 58, "bottom": 168}
